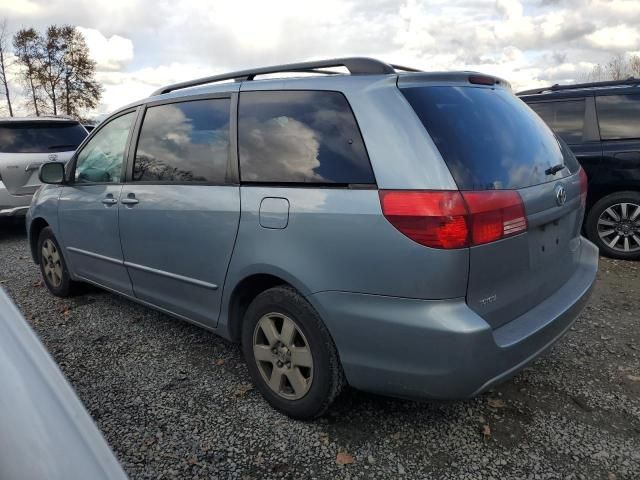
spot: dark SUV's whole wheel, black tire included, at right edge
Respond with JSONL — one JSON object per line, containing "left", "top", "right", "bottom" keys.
{"left": 586, "top": 191, "right": 640, "bottom": 260}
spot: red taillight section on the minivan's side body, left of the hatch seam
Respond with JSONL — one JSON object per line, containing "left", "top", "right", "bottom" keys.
{"left": 380, "top": 190, "right": 469, "bottom": 248}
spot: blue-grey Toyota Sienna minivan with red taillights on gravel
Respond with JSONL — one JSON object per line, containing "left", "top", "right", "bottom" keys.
{"left": 27, "top": 58, "right": 598, "bottom": 418}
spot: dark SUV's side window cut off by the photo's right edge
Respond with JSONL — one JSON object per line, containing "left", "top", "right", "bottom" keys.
{"left": 596, "top": 95, "right": 640, "bottom": 140}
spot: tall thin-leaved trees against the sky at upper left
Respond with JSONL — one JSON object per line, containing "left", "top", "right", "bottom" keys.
{"left": 0, "top": 19, "right": 102, "bottom": 118}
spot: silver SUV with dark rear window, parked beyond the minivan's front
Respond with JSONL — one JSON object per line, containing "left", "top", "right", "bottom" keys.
{"left": 0, "top": 116, "right": 87, "bottom": 217}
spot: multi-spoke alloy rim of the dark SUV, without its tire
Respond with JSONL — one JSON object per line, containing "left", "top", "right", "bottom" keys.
{"left": 598, "top": 202, "right": 640, "bottom": 253}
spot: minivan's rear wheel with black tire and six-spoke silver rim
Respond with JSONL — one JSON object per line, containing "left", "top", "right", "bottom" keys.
{"left": 242, "top": 286, "right": 344, "bottom": 420}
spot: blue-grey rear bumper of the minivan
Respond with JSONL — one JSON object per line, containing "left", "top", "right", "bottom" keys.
{"left": 310, "top": 238, "right": 598, "bottom": 399}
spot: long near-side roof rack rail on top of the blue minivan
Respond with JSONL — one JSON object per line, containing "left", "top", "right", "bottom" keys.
{"left": 151, "top": 57, "right": 420, "bottom": 96}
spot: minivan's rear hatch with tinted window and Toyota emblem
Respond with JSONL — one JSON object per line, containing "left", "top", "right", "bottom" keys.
{"left": 398, "top": 77, "right": 584, "bottom": 328}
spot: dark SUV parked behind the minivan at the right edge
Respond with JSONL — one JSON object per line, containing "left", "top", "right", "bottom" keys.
{"left": 518, "top": 79, "right": 640, "bottom": 260}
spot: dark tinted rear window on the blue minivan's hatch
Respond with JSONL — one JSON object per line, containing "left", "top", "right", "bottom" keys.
{"left": 402, "top": 87, "right": 569, "bottom": 190}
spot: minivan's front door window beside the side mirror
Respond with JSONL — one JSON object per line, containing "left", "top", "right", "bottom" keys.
{"left": 75, "top": 112, "right": 135, "bottom": 183}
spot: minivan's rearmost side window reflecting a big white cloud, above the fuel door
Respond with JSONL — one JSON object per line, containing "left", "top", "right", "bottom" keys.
{"left": 238, "top": 90, "right": 375, "bottom": 184}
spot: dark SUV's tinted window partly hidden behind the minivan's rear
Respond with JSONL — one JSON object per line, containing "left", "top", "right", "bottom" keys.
{"left": 529, "top": 99, "right": 584, "bottom": 144}
